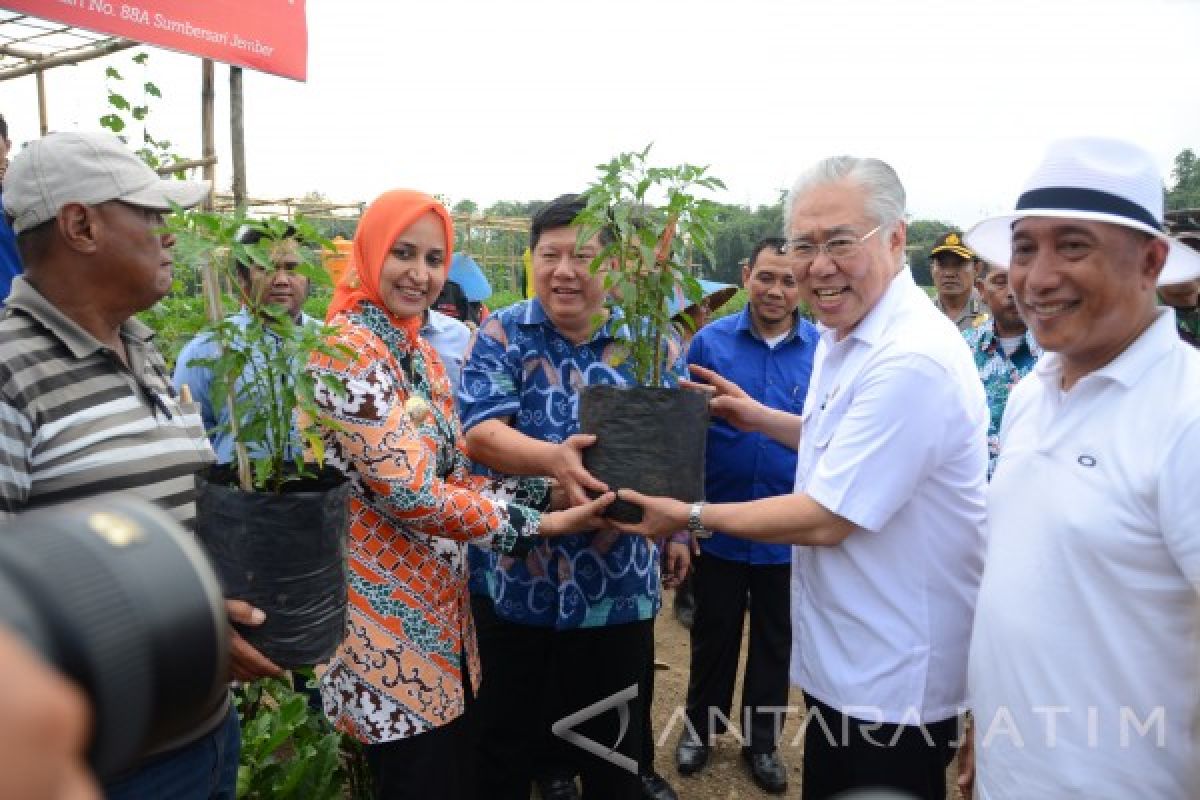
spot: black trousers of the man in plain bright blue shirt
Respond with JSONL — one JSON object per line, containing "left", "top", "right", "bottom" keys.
{"left": 685, "top": 553, "right": 792, "bottom": 753}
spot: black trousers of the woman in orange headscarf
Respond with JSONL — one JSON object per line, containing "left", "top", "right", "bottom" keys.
{"left": 364, "top": 671, "right": 478, "bottom": 800}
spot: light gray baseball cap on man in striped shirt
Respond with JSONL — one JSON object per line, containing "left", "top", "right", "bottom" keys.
{"left": 4, "top": 133, "right": 209, "bottom": 234}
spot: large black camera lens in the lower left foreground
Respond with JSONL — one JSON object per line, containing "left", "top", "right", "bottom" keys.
{"left": 0, "top": 497, "right": 229, "bottom": 776}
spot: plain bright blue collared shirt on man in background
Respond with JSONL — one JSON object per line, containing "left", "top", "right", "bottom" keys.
{"left": 688, "top": 307, "right": 818, "bottom": 565}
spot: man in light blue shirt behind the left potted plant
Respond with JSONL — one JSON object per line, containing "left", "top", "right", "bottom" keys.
{"left": 172, "top": 227, "right": 319, "bottom": 464}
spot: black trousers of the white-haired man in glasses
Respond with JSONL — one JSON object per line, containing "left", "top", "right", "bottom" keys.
{"left": 800, "top": 693, "right": 961, "bottom": 800}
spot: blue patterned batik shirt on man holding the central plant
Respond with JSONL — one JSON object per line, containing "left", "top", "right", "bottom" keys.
{"left": 458, "top": 299, "right": 685, "bottom": 630}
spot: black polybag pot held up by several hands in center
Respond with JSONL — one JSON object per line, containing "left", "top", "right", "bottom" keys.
{"left": 580, "top": 386, "right": 708, "bottom": 523}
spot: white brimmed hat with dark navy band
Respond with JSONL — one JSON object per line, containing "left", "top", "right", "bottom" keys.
{"left": 966, "top": 137, "right": 1200, "bottom": 285}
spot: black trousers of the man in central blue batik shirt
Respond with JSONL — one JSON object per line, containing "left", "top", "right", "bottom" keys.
{"left": 472, "top": 596, "right": 654, "bottom": 800}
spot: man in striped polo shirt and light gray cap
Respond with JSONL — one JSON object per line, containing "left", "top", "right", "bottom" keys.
{"left": 0, "top": 133, "right": 280, "bottom": 800}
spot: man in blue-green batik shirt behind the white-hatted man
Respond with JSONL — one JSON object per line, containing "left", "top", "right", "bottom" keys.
{"left": 962, "top": 263, "right": 1042, "bottom": 479}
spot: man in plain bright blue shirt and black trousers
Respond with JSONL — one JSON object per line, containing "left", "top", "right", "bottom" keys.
{"left": 676, "top": 239, "right": 817, "bottom": 793}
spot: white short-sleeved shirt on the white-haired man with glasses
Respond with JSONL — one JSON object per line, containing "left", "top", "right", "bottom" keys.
{"left": 792, "top": 269, "right": 988, "bottom": 724}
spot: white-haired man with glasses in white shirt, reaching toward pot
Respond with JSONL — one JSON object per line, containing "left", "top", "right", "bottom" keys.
{"left": 620, "top": 157, "right": 988, "bottom": 800}
